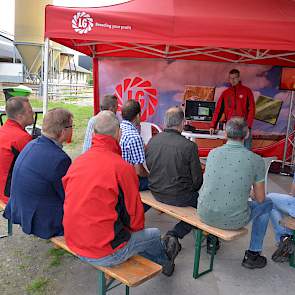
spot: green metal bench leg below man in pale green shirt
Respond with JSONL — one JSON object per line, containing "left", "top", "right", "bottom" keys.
{"left": 193, "top": 228, "right": 217, "bottom": 279}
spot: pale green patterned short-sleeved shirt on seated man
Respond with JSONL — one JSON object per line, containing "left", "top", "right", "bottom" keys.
{"left": 198, "top": 141, "right": 265, "bottom": 229}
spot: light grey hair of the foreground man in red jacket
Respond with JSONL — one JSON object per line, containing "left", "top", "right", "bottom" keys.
{"left": 94, "top": 111, "right": 120, "bottom": 136}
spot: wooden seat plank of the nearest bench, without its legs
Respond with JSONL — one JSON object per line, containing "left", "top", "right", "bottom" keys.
{"left": 50, "top": 237, "right": 162, "bottom": 287}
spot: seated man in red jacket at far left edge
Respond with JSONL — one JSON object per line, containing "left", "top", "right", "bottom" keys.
{"left": 0, "top": 96, "right": 34, "bottom": 203}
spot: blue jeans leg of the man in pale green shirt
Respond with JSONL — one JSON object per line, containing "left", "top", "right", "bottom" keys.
{"left": 249, "top": 198, "right": 272, "bottom": 252}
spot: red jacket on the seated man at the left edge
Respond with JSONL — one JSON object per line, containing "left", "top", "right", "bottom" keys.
{"left": 0, "top": 119, "right": 32, "bottom": 203}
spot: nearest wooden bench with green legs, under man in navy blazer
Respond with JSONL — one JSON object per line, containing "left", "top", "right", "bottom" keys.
{"left": 50, "top": 237, "right": 162, "bottom": 295}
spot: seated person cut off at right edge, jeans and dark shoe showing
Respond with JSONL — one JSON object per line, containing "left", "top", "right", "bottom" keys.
{"left": 267, "top": 174, "right": 295, "bottom": 262}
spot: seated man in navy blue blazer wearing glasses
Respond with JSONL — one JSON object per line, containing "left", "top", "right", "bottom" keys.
{"left": 4, "top": 108, "right": 73, "bottom": 239}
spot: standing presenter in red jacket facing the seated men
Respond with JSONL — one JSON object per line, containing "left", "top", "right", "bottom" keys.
{"left": 210, "top": 69, "right": 255, "bottom": 149}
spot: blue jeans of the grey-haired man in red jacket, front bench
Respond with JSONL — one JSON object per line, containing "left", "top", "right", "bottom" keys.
{"left": 79, "top": 228, "right": 169, "bottom": 266}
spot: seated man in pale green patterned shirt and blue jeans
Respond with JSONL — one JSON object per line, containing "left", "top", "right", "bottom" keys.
{"left": 197, "top": 117, "right": 272, "bottom": 269}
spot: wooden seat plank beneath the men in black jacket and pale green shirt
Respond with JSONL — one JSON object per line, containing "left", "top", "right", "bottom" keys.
{"left": 140, "top": 191, "right": 248, "bottom": 241}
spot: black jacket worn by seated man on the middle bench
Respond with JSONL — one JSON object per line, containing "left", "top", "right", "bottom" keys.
{"left": 146, "top": 129, "right": 203, "bottom": 205}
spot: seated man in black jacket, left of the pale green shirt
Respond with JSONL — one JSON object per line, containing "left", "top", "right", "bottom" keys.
{"left": 146, "top": 107, "right": 203, "bottom": 247}
